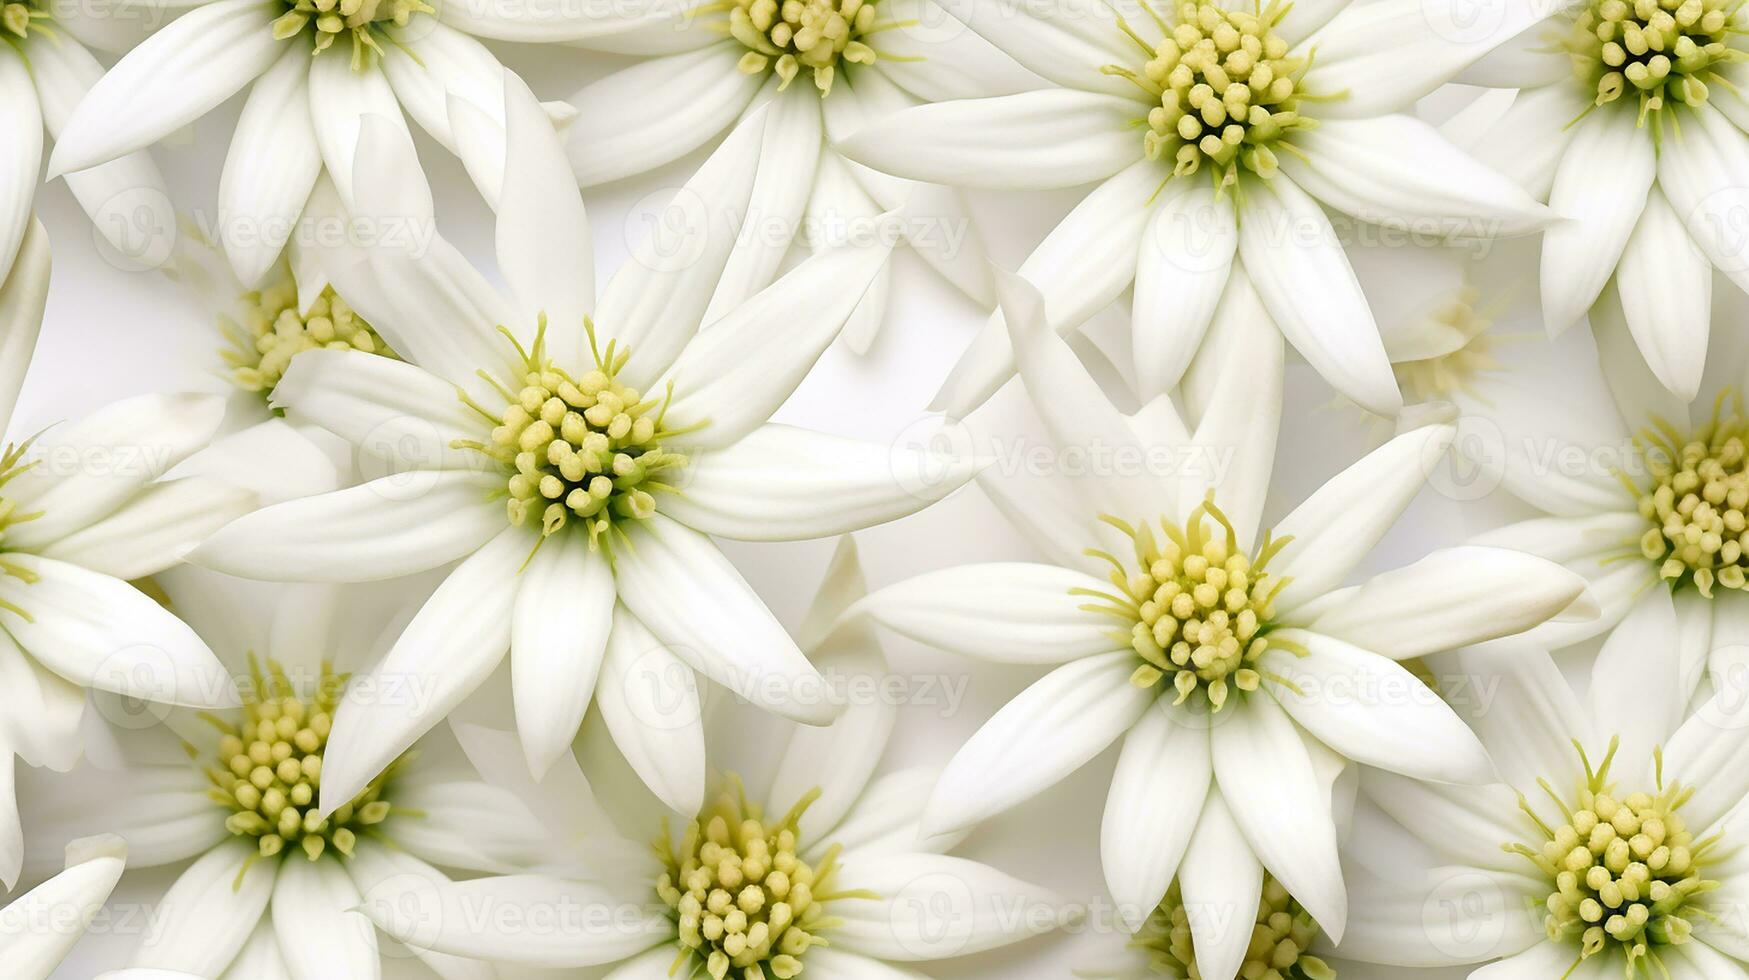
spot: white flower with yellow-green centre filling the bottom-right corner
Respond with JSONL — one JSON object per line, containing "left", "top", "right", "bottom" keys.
{"left": 1340, "top": 640, "right": 1749, "bottom": 980}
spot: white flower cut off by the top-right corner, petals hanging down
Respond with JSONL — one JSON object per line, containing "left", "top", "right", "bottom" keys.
{"left": 1466, "top": 0, "right": 1749, "bottom": 401}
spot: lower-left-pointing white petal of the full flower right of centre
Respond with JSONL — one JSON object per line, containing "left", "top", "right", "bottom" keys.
{"left": 923, "top": 649, "right": 1154, "bottom": 835}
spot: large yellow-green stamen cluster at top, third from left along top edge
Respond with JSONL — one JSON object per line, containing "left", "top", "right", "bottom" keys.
{"left": 1102, "top": 0, "right": 1315, "bottom": 187}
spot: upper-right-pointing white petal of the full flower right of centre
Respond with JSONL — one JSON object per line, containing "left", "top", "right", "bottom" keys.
{"left": 1272, "top": 425, "right": 1455, "bottom": 614}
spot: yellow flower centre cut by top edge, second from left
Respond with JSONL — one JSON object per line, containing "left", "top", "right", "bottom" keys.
{"left": 719, "top": 0, "right": 897, "bottom": 95}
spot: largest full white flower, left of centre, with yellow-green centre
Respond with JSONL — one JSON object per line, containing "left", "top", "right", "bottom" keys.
{"left": 194, "top": 79, "right": 976, "bottom": 812}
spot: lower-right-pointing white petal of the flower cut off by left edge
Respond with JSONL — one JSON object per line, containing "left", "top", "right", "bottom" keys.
{"left": 0, "top": 553, "right": 240, "bottom": 707}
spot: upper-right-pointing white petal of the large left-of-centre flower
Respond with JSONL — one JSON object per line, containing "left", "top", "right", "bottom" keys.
{"left": 658, "top": 227, "right": 892, "bottom": 448}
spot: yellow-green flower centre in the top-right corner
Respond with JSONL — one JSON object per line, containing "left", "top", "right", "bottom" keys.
{"left": 1567, "top": 0, "right": 1744, "bottom": 123}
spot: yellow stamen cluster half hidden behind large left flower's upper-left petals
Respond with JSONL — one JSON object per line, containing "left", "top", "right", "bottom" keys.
{"left": 219, "top": 275, "right": 397, "bottom": 396}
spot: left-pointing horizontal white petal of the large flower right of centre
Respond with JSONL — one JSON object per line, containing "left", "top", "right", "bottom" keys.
{"left": 855, "top": 562, "right": 1118, "bottom": 663}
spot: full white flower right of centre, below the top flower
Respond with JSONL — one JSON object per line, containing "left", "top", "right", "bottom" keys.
{"left": 857, "top": 266, "right": 1585, "bottom": 977}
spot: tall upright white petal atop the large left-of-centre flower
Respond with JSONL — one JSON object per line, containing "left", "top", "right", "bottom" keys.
{"left": 497, "top": 70, "right": 595, "bottom": 375}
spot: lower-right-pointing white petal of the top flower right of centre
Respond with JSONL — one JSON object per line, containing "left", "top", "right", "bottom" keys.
{"left": 1238, "top": 175, "right": 1403, "bottom": 418}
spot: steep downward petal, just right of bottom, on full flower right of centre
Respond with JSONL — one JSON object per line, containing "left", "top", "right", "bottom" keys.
{"left": 1210, "top": 697, "right": 1348, "bottom": 942}
